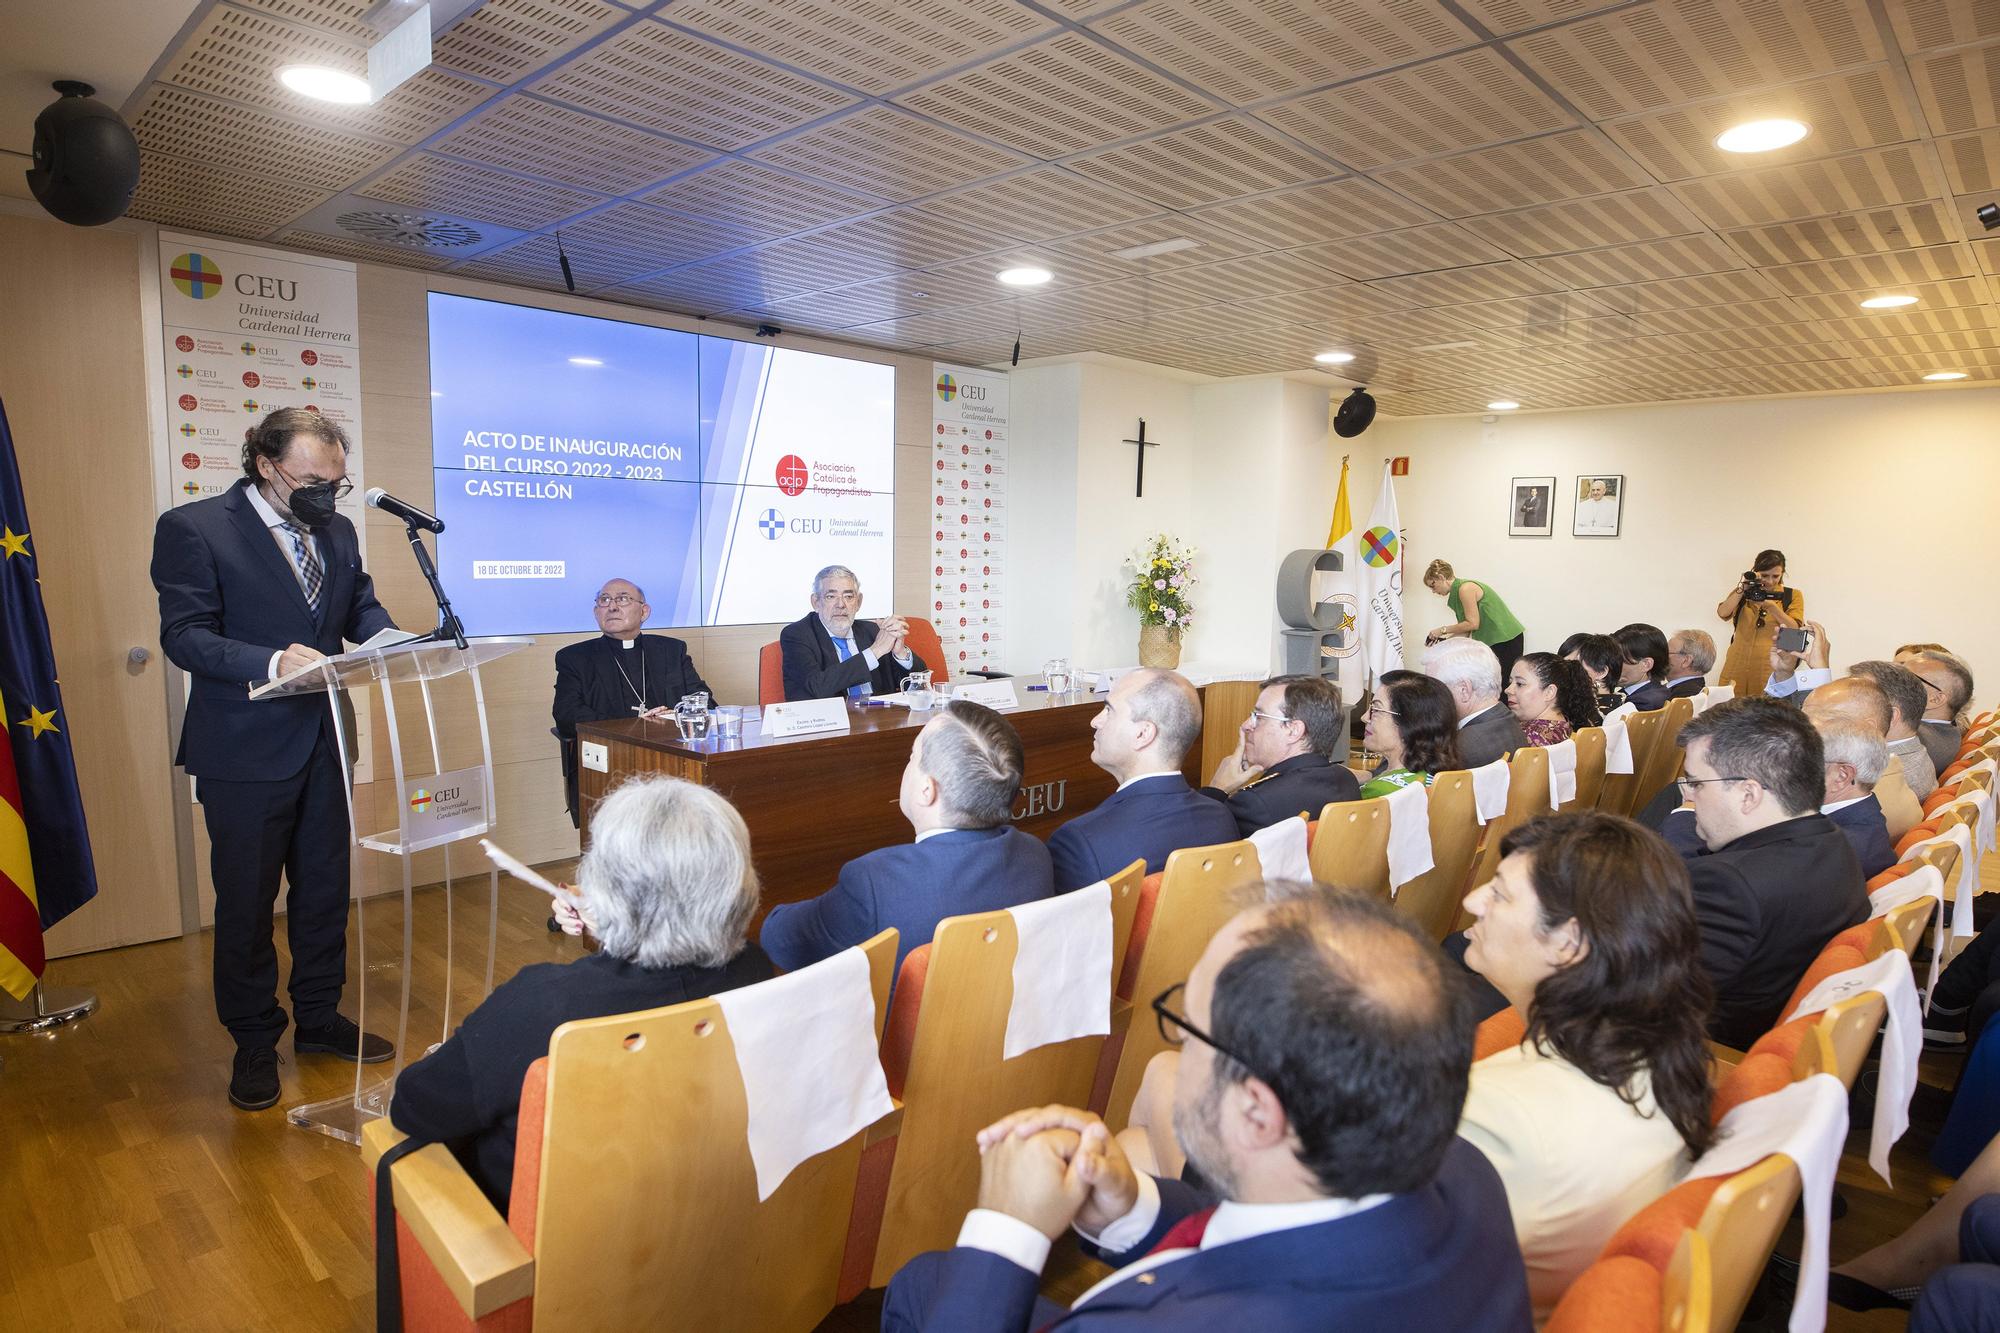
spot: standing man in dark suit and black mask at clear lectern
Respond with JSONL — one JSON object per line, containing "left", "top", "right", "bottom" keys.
{"left": 152, "top": 408, "right": 394, "bottom": 1111}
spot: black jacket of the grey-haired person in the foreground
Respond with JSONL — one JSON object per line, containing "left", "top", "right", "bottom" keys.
{"left": 388, "top": 945, "right": 772, "bottom": 1213}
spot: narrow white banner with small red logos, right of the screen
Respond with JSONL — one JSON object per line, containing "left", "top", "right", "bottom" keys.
{"left": 930, "top": 364, "right": 1008, "bottom": 677}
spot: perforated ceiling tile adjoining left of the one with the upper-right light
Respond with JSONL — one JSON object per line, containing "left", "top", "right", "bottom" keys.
{"left": 1374, "top": 130, "right": 1652, "bottom": 215}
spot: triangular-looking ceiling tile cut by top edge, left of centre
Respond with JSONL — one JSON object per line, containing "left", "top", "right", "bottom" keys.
{"left": 662, "top": 0, "right": 1052, "bottom": 94}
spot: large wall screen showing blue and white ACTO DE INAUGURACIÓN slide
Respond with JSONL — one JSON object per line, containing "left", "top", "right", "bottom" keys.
{"left": 430, "top": 292, "right": 896, "bottom": 634}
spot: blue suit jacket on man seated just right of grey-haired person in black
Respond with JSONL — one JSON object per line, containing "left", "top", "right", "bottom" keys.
{"left": 760, "top": 827, "right": 1056, "bottom": 973}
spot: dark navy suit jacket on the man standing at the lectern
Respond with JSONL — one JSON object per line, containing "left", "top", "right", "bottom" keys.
{"left": 152, "top": 480, "right": 396, "bottom": 783}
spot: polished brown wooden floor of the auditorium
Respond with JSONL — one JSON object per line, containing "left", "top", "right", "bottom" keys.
{"left": 0, "top": 867, "right": 1984, "bottom": 1333}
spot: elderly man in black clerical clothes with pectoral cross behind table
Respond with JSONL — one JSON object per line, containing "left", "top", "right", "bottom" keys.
{"left": 554, "top": 578, "right": 714, "bottom": 825}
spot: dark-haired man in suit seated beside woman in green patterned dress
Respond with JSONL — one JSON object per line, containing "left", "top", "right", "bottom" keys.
{"left": 1202, "top": 677, "right": 1360, "bottom": 839}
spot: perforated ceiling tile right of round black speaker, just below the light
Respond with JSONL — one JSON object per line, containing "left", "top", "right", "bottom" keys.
{"left": 132, "top": 84, "right": 396, "bottom": 192}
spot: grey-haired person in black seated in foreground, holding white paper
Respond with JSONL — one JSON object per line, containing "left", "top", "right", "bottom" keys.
{"left": 388, "top": 777, "right": 772, "bottom": 1213}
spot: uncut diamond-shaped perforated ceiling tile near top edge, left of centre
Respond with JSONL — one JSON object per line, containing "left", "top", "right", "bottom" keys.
{"left": 532, "top": 22, "right": 854, "bottom": 148}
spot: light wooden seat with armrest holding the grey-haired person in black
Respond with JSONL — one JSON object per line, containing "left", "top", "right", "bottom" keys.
{"left": 362, "top": 931, "right": 896, "bottom": 1333}
